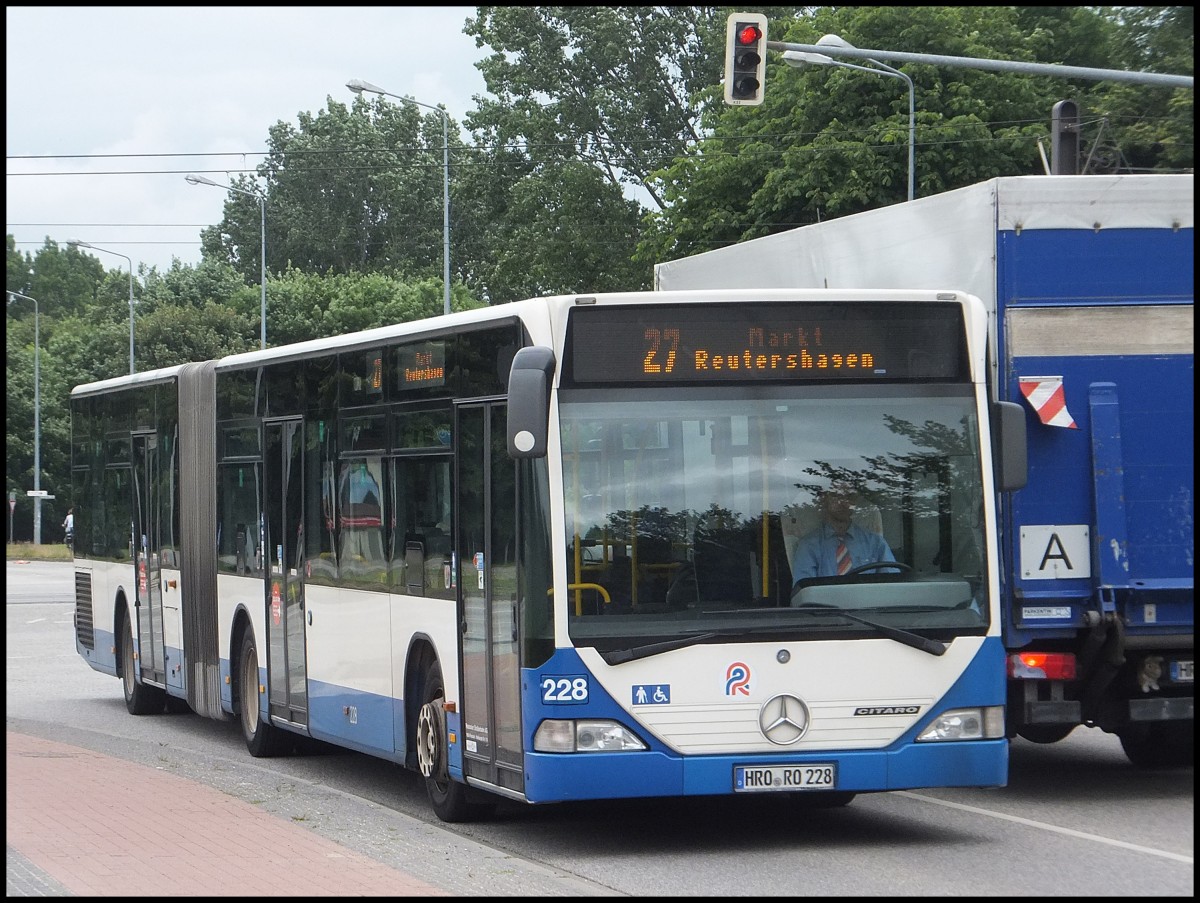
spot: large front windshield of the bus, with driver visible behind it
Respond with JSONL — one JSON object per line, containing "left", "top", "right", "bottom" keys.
{"left": 559, "top": 384, "right": 988, "bottom": 651}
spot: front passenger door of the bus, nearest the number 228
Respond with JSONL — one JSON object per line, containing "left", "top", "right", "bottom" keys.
{"left": 455, "top": 402, "right": 524, "bottom": 793}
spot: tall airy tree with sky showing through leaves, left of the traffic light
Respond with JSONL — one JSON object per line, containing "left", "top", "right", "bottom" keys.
{"left": 464, "top": 6, "right": 725, "bottom": 207}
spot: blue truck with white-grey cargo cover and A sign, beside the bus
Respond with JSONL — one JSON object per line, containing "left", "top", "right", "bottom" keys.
{"left": 654, "top": 174, "right": 1195, "bottom": 767}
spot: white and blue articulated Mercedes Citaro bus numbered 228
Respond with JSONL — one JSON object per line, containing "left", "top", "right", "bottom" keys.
{"left": 71, "top": 289, "right": 1025, "bottom": 821}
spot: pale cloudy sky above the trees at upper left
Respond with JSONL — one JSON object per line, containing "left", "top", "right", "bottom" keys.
{"left": 5, "top": 6, "right": 486, "bottom": 270}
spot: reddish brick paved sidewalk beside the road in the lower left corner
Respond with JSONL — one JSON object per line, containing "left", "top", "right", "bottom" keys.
{"left": 5, "top": 731, "right": 448, "bottom": 897}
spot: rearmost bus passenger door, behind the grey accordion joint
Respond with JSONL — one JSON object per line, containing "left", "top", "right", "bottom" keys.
{"left": 133, "top": 432, "right": 167, "bottom": 686}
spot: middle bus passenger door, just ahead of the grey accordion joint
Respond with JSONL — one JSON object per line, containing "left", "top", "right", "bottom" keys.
{"left": 263, "top": 418, "right": 308, "bottom": 725}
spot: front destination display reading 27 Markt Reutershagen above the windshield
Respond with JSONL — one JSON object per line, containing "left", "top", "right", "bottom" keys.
{"left": 568, "top": 301, "right": 967, "bottom": 385}
